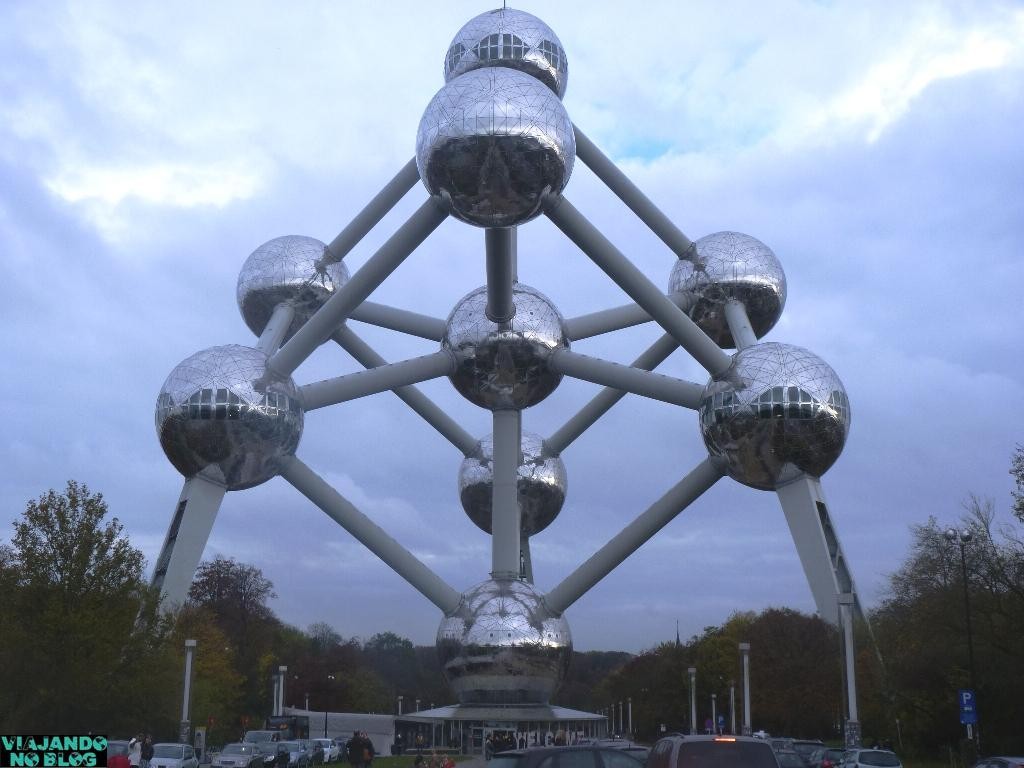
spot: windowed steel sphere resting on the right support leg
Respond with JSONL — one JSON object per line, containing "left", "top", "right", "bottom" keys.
{"left": 699, "top": 342, "right": 850, "bottom": 490}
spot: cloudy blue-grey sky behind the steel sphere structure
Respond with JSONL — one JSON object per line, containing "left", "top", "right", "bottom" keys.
{"left": 0, "top": 0, "right": 1024, "bottom": 651}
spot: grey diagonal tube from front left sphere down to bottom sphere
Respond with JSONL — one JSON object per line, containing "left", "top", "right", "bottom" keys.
{"left": 281, "top": 456, "right": 460, "bottom": 613}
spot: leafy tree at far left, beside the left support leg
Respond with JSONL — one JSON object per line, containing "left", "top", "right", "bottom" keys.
{"left": 0, "top": 480, "right": 167, "bottom": 733}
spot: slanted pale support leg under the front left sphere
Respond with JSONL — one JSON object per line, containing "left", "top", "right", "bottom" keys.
{"left": 151, "top": 475, "right": 225, "bottom": 610}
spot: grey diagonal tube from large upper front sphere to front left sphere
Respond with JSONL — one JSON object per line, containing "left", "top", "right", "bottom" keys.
{"left": 268, "top": 198, "right": 447, "bottom": 376}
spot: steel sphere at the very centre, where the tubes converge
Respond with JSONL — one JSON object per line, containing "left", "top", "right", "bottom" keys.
{"left": 441, "top": 283, "right": 569, "bottom": 411}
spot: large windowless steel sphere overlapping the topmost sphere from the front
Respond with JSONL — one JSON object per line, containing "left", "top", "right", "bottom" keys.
{"left": 416, "top": 67, "right": 575, "bottom": 226}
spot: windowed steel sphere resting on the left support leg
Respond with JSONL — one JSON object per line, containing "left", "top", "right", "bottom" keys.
{"left": 156, "top": 344, "right": 303, "bottom": 490}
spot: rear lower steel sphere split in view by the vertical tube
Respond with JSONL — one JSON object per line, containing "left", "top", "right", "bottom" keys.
{"left": 459, "top": 432, "right": 568, "bottom": 536}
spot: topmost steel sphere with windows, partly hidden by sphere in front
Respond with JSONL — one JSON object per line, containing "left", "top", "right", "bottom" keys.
{"left": 444, "top": 8, "right": 569, "bottom": 98}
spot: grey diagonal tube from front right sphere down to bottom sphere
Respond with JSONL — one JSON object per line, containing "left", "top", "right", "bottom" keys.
{"left": 544, "top": 459, "right": 722, "bottom": 613}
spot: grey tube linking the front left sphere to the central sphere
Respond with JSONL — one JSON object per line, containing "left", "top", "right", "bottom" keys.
{"left": 299, "top": 349, "right": 455, "bottom": 411}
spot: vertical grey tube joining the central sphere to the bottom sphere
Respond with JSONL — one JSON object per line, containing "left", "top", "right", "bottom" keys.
{"left": 490, "top": 410, "right": 522, "bottom": 579}
